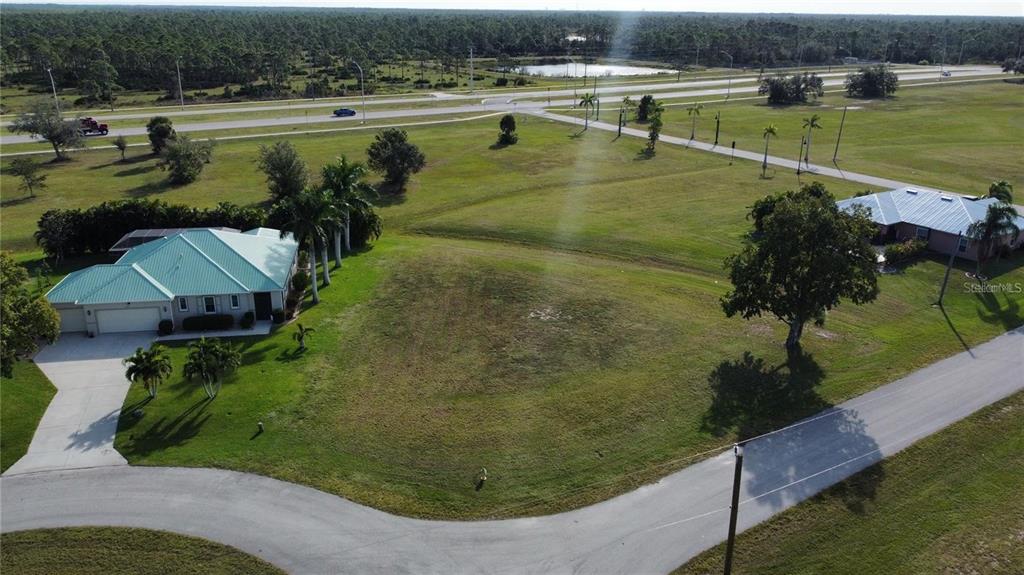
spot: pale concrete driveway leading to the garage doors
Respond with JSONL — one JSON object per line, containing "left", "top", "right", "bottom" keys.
{"left": 4, "top": 333, "right": 154, "bottom": 475}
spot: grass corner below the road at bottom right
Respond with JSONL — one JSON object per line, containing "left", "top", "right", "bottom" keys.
{"left": 675, "top": 393, "right": 1024, "bottom": 575}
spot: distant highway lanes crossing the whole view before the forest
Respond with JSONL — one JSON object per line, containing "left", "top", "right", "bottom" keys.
{"left": 0, "top": 67, "right": 1001, "bottom": 144}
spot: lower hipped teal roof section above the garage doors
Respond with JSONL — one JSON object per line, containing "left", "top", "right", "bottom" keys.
{"left": 46, "top": 264, "right": 174, "bottom": 305}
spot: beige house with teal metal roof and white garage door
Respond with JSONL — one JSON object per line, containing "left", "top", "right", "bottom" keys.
{"left": 46, "top": 228, "right": 298, "bottom": 335}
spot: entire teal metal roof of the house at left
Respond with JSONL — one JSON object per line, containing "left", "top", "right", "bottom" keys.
{"left": 47, "top": 228, "right": 298, "bottom": 304}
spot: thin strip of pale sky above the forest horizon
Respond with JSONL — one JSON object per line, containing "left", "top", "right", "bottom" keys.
{"left": 8, "top": 0, "right": 1024, "bottom": 17}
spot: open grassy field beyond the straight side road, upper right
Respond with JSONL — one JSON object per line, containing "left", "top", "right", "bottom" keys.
{"left": 651, "top": 82, "right": 1024, "bottom": 193}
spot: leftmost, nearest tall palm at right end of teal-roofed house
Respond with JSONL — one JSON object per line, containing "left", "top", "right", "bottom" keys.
{"left": 274, "top": 188, "right": 337, "bottom": 304}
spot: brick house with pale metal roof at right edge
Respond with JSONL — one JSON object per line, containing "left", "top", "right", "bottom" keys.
{"left": 837, "top": 187, "right": 1024, "bottom": 261}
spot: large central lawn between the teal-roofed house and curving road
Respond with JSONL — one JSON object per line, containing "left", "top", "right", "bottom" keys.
{"left": 2, "top": 93, "right": 1024, "bottom": 519}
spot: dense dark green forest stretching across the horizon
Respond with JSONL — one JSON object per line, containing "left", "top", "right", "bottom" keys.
{"left": 0, "top": 6, "right": 1024, "bottom": 97}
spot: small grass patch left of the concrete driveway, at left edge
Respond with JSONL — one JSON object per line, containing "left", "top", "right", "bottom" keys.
{"left": 0, "top": 360, "right": 57, "bottom": 472}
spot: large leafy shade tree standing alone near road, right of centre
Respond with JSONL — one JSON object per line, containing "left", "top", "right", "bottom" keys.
{"left": 722, "top": 184, "right": 879, "bottom": 352}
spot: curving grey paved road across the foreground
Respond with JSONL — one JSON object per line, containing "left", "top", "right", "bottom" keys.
{"left": 0, "top": 327, "right": 1024, "bottom": 574}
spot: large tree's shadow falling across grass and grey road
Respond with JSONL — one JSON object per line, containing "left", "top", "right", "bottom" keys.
{"left": 702, "top": 352, "right": 885, "bottom": 513}
